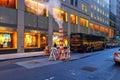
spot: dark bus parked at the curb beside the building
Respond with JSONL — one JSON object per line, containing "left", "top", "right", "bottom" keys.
{"left": 70, "top": 33, "right": 105, "bottom": 52}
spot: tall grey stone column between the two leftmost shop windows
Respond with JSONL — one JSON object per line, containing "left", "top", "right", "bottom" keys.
{"left": 17, "top": 0, "right": 25, "bottom": 53}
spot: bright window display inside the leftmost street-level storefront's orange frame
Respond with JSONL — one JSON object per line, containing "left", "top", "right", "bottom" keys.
{"left": 0, "top": 33, "right": 12, "bottom": 48}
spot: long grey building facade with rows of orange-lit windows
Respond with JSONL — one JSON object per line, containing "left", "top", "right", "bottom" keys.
{"left": 0, "top": 0, "right": 114, "bottom": 53}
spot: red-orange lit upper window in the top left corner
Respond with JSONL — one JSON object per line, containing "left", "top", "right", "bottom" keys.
{"left": 0, "top": 0, "right": 16, "bottom": 8}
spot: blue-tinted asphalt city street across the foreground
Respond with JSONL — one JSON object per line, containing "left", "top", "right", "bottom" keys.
{"left": 0, "top": 48, "right": 120, "bottom": 80}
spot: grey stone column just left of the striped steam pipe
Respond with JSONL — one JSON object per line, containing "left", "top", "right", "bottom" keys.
{"left": 48, "top": 14, "right": 53, "bottom": 46}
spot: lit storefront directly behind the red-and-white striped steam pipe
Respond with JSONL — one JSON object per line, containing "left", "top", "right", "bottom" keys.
{"left": 52, "top": 32, "right": 68, "bottom": 47}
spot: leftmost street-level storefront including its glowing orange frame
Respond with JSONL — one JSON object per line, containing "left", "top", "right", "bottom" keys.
{"left": 0, "top": 27, "right": 17, "bottom": 54}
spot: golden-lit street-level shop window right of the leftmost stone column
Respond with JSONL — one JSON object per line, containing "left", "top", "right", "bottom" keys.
{"left": 24, "top": 33, "right": 38, "bottom": 48}
